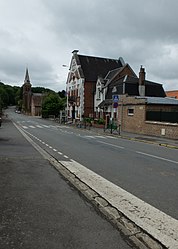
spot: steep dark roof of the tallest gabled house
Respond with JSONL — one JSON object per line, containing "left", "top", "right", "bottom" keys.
{"left": 77, "top": 54, "right": 123, "bottom": 82}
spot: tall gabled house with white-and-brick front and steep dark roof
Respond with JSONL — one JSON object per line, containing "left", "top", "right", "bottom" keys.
{"left": 66, "top": 50, "right": 125, "bottom": 120}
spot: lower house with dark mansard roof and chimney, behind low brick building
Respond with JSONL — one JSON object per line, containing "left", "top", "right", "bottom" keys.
{"left": 95, "top": 64, "right": 166, "bottom": 119}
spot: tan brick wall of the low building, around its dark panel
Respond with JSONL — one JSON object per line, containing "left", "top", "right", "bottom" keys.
{"left": 118, "top": 97, "right": 178, "bottom": 139}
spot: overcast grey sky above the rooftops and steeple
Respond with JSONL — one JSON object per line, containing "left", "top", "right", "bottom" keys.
{"left": 0, "top": 0, "right": 178, "bottom": 91}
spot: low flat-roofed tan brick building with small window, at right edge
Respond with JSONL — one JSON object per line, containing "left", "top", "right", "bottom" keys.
{"left": 118, "top": 95, "right": 178, "bottom": 139}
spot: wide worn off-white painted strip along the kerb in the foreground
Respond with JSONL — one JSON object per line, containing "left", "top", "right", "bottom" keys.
{"left": 60, "top": 160, "right": 178, "bottom": 249}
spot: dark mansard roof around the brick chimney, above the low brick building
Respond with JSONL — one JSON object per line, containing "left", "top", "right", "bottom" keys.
{"left": 106, "top": 76, "right": 166, "bottom": 99}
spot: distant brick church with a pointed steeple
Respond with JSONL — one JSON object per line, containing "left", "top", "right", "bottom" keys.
{"left": 22, "top": 68, "right": 42, "bottom": 116}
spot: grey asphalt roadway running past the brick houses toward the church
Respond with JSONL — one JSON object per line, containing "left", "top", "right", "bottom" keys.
{"left": 7, "top": 107, "right": 178, "bottom": 219}
